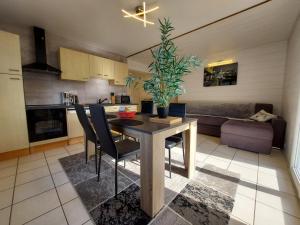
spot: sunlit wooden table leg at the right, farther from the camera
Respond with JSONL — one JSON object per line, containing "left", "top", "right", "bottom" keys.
{"left": 184, "top": 121, "right": 197, "bottom": 179}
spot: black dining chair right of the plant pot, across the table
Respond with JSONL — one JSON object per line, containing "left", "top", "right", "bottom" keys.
{"left": 165, "top": 103, "right": 186, "bottom": 178}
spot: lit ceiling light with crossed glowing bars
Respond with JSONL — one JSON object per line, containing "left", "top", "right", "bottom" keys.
{"left": 121, "top": 2, "right": 159, "bottom": 27}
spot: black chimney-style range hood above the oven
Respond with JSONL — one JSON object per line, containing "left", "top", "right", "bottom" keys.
{"left": 22, "top": 27, "right": 61, "bottom": 75}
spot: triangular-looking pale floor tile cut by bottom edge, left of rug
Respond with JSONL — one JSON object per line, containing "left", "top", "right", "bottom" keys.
{"left": 26, "top": 207, "right": 67, "bottom": 225}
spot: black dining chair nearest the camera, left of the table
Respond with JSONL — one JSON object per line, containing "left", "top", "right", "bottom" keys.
{"left": 90, "top": 105, "right": 140, "bottom": 195}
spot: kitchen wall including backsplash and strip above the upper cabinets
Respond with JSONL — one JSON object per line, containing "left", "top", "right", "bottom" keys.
{"left": 0, "top": 24, "right": 126, "bottom": 105}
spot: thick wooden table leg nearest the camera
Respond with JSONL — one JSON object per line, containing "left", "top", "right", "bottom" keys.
{"left": 140, "top": 134, "right": 165, "bottom": 217}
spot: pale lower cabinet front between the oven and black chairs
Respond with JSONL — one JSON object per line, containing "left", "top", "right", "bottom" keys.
{"left": 67, "top": 110, "right": 84, "bottom": 139}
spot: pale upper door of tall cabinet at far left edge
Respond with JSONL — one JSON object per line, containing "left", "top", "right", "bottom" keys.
{"left": 0, "top": 31, "right": 22, "bottom": 75}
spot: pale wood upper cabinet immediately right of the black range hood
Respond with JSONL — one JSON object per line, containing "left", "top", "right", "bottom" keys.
{"left": 59, "top": 48, "right": 90, "bottom": 81}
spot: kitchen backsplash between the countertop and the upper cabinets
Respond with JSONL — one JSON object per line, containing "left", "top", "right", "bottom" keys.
{"left": 23, "top": 72, "right": 126, "bottom": 105}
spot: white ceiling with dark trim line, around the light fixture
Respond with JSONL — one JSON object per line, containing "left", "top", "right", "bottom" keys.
{"left": 0, "top": 0, "right": 300, "bottom": 67}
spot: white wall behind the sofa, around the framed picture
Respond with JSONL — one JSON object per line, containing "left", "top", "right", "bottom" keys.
{"left": 179, "top": 41, "right": 287, "bottom": 114}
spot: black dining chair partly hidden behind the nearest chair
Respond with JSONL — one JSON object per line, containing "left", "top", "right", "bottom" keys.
{"left": 75, "top": 104, "right": 122, "bottom": 172}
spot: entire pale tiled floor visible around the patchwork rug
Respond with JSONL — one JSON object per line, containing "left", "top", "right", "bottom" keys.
{"left": 0, "top": 135, "right": 300, "bottom": 225}
